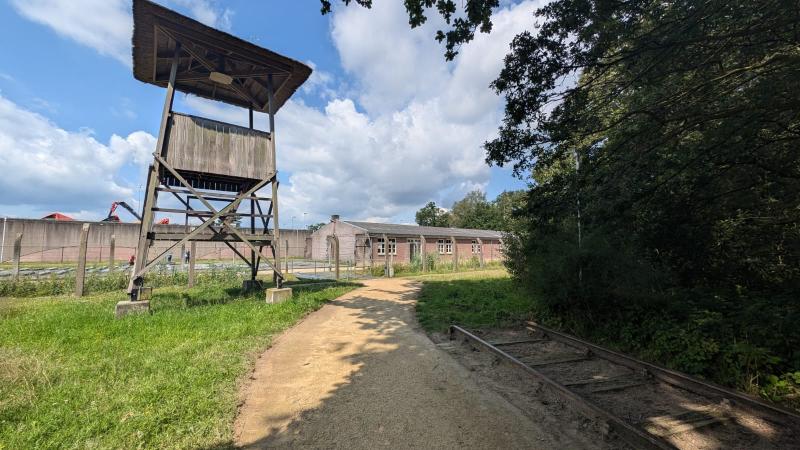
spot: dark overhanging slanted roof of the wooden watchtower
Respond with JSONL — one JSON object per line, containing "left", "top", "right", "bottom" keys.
{"left": 133, "top": 0, "right": 311, "bottom": 112}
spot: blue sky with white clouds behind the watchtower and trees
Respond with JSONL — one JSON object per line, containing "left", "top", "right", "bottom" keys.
{"left": 0, "top": 0, "right": 535, "bottom": 226}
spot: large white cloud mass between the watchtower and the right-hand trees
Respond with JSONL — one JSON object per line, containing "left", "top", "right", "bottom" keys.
{"left": 184, "top": 2, "right": 535, "bottom": 224}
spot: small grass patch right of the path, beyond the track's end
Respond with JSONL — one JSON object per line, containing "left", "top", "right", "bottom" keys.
{"left": 415, "top": 269, "right": 534, "bottom": 332}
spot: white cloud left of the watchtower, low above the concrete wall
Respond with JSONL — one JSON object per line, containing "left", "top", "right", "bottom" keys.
{"left": 0, "top": 97, "right": 156, "bottom": 218}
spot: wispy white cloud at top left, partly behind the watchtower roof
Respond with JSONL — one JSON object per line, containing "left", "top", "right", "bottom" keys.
{"left": 11, "top": 0, "right": 233, "bottom": 66}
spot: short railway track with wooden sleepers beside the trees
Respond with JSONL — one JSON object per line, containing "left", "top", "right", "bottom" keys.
{"left": 450, "top": 322, "right": 800, "bottom": 449}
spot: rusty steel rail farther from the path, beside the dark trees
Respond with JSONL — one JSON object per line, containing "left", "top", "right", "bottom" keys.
{"left": 527, "top": 321, "right": 800, "bottom": 425}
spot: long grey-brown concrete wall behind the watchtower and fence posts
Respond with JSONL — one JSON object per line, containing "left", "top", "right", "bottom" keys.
{"left": 0, "top": 219, "right": 311, "bottom": 262}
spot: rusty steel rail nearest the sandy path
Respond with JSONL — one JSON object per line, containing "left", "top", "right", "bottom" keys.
{"left": 450, "top": 325, "right": 676, "bottom": 449}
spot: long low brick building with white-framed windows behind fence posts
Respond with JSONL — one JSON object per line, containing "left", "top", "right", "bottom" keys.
{"left": 311, "top": 216, "right": 503, "bottom": 265}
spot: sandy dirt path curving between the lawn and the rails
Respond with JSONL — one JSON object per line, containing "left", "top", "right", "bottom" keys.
{"left": 236, "top": 279, "right": 587, "bottom": 449}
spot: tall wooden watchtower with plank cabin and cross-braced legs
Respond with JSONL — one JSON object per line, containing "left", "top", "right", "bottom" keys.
{"left": 128, "top": 0, "right": 311, "bottom": 300}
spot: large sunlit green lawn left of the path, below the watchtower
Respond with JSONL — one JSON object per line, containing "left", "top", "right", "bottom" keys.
{"left": 0, "top": 283, "right": 354, "bottom": 449}
